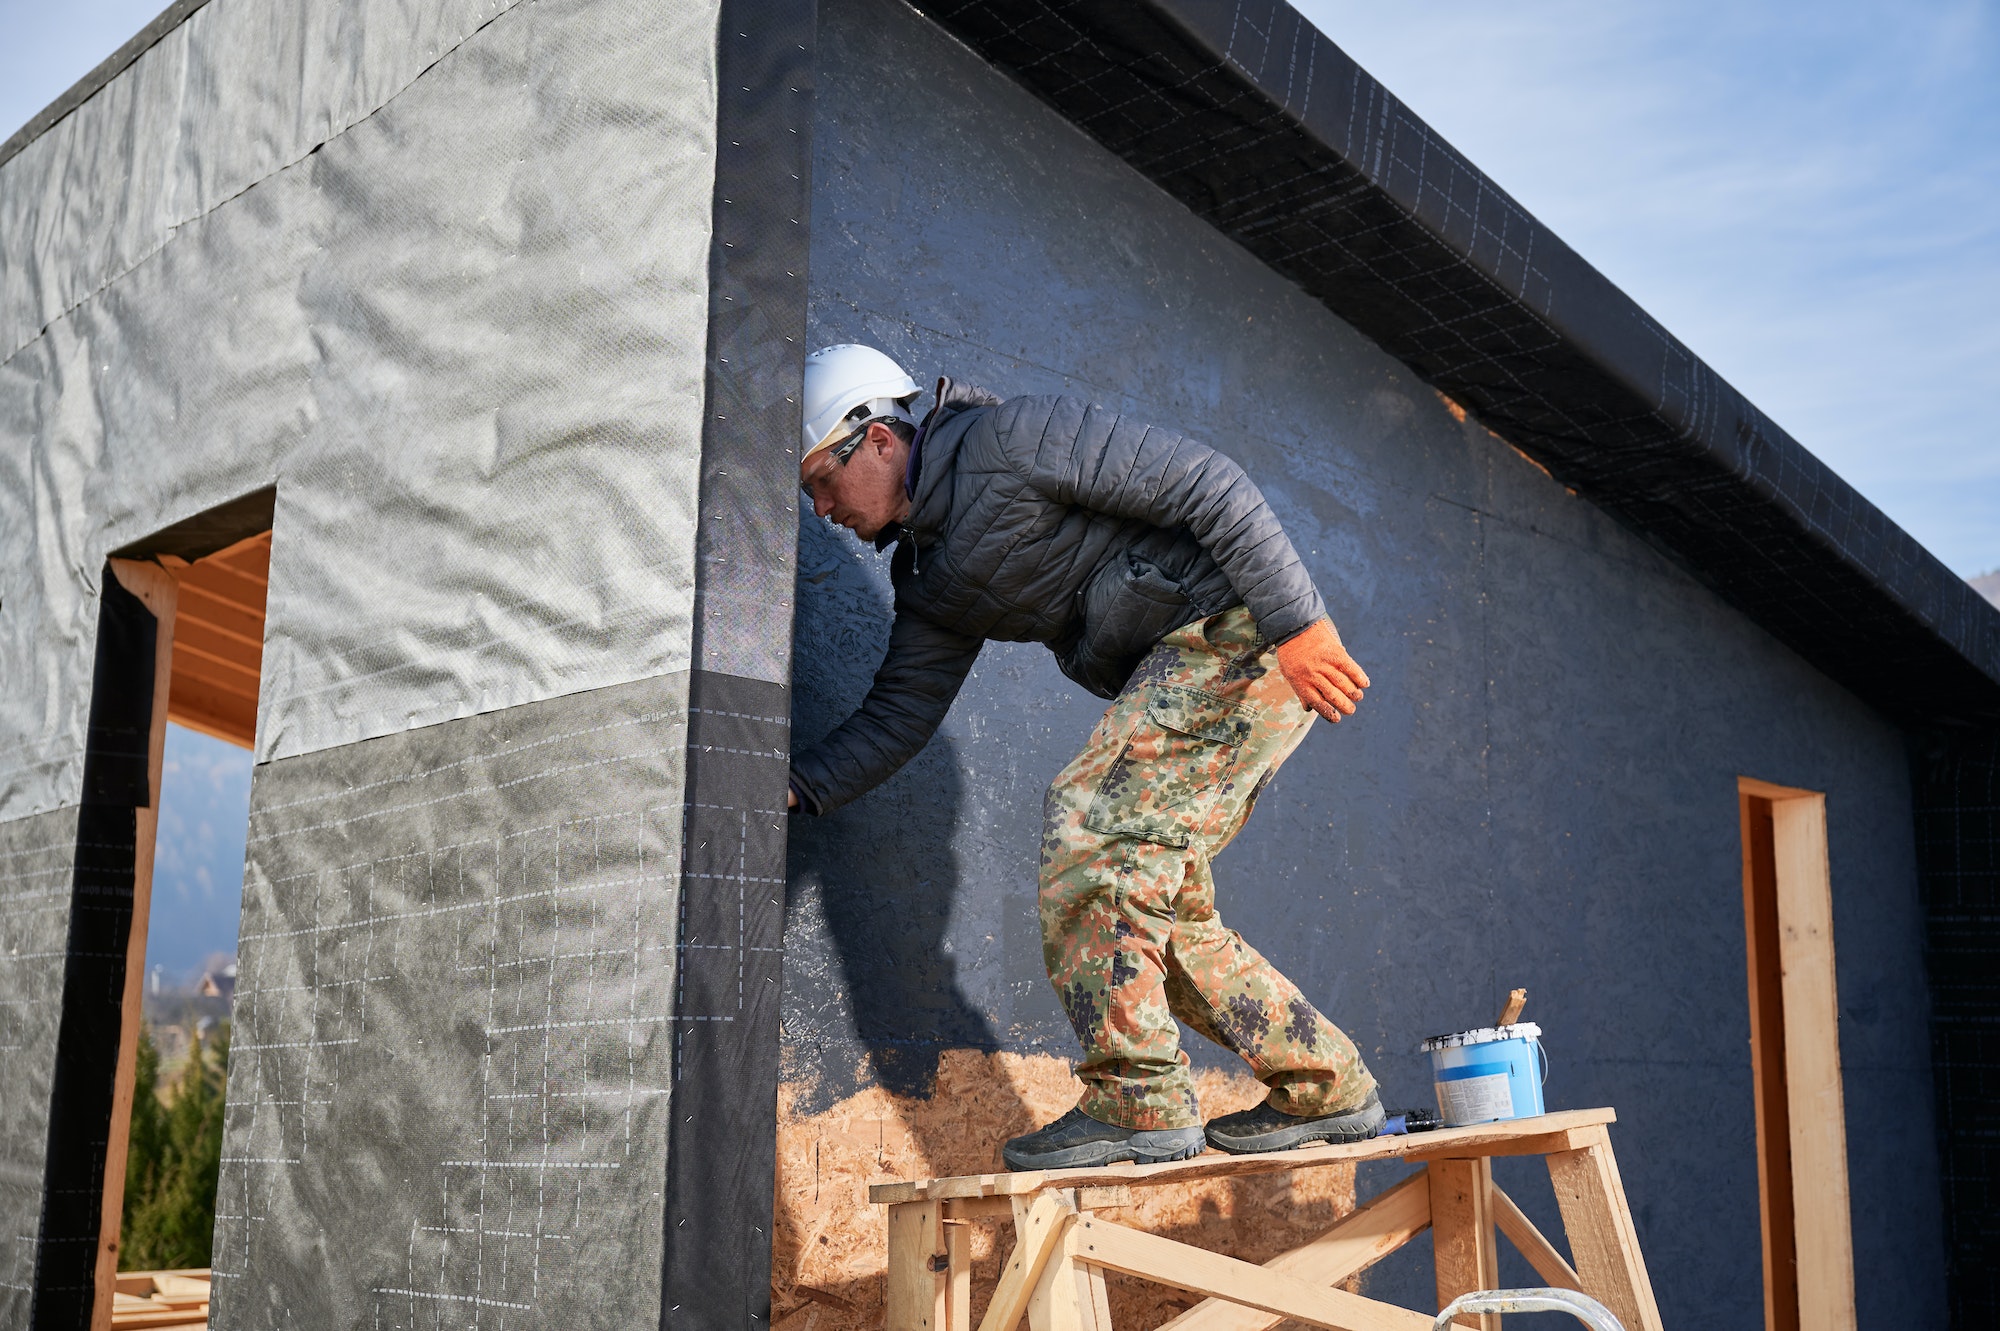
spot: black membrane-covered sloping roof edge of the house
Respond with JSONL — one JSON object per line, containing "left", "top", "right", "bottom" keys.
{"left": 15, "top": 0, "right": 2000, "bottom": 723}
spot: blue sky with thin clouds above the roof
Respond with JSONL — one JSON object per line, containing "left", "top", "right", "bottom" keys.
{"left": 0, "top": 0, "right": 2000, "bottom": 576}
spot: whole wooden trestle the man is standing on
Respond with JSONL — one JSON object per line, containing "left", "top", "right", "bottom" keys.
{"left": 868, "top": 1109, "right": 1662, "bottom": 1331}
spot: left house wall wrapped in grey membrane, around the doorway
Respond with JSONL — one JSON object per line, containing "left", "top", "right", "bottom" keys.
{"left": 0, "top": 0, "right": 756, "bottom": 1327}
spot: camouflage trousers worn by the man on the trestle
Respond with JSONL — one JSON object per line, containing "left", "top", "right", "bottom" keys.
{"left": 1040, "top": 608, "right": 1374, "bottom": 1129}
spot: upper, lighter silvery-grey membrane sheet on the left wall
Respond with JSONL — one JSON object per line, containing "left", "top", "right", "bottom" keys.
{"left": 0, "top": 0, "right": 716, "bottom": 819}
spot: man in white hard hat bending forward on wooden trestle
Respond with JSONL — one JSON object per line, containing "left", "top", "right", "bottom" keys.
{"left": 790, "top": 346, "right": 1382, "bottom": 1169}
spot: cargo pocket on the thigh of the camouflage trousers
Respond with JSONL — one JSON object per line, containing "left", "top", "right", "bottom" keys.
{"left": 1084, "top": 685, "right": 1256, "bottom": 845}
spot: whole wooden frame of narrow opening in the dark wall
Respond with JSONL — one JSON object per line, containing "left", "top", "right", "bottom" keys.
{"left": 1736, "top": 777, "right": 1856, "bottom": 1331}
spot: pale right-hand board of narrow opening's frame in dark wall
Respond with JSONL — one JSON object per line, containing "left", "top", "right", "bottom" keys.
{"left": 1770, "top": 795, "right": 1856, "bottom": 1331}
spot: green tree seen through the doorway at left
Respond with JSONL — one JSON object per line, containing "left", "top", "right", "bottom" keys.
{"left": 118, "top": 1025, "right": 230, "bottom": 1271}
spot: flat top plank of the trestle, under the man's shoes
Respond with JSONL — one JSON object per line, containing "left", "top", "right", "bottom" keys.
{"left": 868, "top": 1109, "right": 1618, "bottom": 1205}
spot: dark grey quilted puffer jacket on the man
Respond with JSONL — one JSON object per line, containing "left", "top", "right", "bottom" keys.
{"left": 792, "top": 380, "right": 1326, "bottom": 813}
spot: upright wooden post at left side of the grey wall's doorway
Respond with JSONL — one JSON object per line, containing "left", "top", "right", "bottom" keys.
{"left": 90, "top": 560, "right": 178, "bottom": 1331}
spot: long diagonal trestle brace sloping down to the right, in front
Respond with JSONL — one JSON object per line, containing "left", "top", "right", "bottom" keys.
{"left": 1074, "top": 1215, "right": 1432, "bottom": 1331}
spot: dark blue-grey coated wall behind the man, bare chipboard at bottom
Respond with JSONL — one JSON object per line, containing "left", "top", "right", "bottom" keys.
{"left": 774, "top": 0, "right": 1944, "bottom": 1327}
